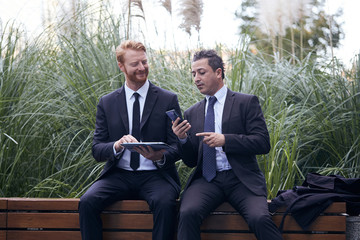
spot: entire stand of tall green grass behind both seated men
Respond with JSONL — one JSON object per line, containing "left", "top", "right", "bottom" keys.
{"left": 0, "top": 3, "right": 360, "bottom": 198}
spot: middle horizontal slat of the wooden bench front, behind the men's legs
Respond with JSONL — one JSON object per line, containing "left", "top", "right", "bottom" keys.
{"left": 7, "top": 212, "right": 346, "bottom": 231}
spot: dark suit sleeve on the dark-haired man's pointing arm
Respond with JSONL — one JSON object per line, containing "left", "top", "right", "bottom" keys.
{"left": 223, "top": 96, "right": 270, "bottom": 155}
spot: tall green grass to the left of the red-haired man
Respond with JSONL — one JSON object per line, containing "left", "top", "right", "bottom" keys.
{"left": 0, "top": 4, "right": 124, "bottom": 197}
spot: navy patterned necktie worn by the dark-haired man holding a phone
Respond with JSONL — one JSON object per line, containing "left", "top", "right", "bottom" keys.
{"left": 203, "top": 96, "right": 216, "bottom": 182}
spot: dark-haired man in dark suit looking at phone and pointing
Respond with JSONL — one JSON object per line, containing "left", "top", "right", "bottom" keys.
{"left": 172, "top": 50, "right": 282, "bottom": 240}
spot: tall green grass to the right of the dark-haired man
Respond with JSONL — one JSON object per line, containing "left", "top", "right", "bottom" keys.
{"left": 228, "top": 50, "right": 360, "bottom": 197}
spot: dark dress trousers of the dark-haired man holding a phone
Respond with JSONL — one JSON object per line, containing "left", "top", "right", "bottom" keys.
{"left": 177, "top": 170, "right": 282, "bottom": 240}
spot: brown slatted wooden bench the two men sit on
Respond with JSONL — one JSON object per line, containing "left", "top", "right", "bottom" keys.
{"left": 0, "top": 198, "right": 346, "bottom": 240}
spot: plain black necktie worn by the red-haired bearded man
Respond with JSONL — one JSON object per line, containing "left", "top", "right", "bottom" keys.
{"left": 130, "top": 92, "right": 140, "bottom": 170}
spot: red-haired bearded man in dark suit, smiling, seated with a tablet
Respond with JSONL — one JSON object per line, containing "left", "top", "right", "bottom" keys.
{"left": 79, "top": 40, "right": 180, "bottom": 240}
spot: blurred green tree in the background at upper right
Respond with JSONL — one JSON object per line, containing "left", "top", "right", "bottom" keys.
{"left": 235, "top": 0, "right": 344, "bottom": 60}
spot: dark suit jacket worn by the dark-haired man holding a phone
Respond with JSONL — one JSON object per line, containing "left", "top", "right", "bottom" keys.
{"left": 182, "top": 89, "right": 270, "bottom": 196}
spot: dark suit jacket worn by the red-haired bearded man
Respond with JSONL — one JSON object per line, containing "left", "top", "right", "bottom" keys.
{"left": 92, "top": 83, "right": 180, "bottom": 191}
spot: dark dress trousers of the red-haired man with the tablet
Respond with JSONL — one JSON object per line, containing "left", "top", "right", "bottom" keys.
{"left": 79, "top": 169, "right": 178, "bottom": 240}
